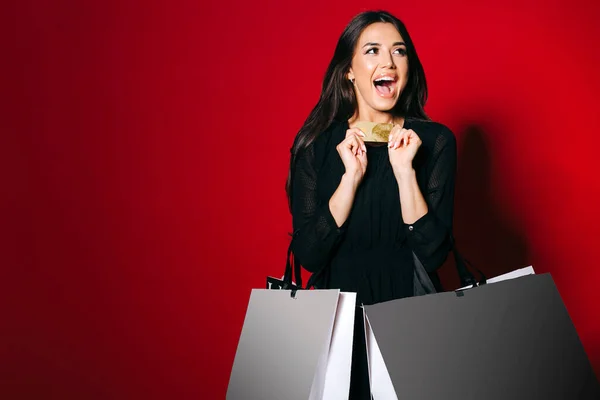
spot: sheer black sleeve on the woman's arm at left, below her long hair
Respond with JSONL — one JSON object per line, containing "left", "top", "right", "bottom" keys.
{"left": 292, "top": 145, "right": 343, "bottom": 272}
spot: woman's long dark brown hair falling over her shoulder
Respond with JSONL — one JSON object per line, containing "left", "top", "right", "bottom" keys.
{"left": 286, "top": 11, "right": 429, "bottom": 210}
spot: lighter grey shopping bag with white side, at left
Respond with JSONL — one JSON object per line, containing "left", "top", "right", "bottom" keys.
{"left": 227, "top": 289, "right": 356, "bottom": 400}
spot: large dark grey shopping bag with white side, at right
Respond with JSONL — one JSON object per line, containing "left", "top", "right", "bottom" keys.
{"left": 364, "top": 274, "right": 600, "bottom": 400}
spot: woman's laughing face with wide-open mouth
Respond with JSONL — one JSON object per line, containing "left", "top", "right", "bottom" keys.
{"left": 348, "top": 22, "right": 408, "bottom": 113}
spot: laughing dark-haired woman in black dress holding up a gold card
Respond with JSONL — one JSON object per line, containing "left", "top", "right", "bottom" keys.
{"left": 287, "top": 12, "right": 456, "bottom": 399}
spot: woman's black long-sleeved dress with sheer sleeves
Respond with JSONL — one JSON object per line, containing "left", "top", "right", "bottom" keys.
{"left": 292, "top": 119, "right": 456, "bottom": 399}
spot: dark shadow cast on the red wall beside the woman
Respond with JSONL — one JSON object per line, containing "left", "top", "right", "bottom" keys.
{"left": 439, "top": 125, "right": 530, "bottom": 290}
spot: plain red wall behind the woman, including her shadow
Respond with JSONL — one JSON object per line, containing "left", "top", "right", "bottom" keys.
{"left": 0, "top": 0, "right": 600, "bottom": 399}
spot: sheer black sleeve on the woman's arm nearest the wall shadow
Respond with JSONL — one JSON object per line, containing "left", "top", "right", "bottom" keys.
{"left": 404, "top": 126, "right": 456, "bottom": 272}
